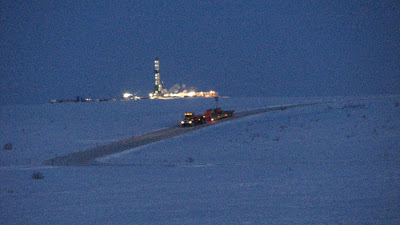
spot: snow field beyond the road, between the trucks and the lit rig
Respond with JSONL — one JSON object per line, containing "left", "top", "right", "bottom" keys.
{"left": 0, "top": 98, "right": 331, "bottom": 167}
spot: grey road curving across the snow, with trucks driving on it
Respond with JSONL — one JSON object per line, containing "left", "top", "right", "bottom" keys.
{"left": 44, "top": 103, "right": 322, "bottom": 166}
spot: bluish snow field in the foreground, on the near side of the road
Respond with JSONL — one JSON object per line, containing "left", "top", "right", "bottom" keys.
{"left": 0, "top": 97, "right": 400, "bottom": 224}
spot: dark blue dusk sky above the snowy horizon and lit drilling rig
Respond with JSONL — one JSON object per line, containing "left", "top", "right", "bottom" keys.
{"left": 0, "top": 0, "right": 400, "bottom": 105}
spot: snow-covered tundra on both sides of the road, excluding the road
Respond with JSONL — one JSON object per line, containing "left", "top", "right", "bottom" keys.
{"left": 0, "top": 96, "right": 400, "bottom": 224}
